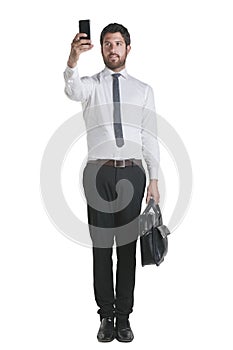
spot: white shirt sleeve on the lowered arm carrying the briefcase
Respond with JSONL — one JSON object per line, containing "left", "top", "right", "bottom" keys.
{"left": 141, "top": 86, "right": 160, "bottom": 180}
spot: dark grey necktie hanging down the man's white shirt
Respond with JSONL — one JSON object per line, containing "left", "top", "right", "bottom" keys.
{"left": 112, "top": 73, "right": 124, "bottom": 147}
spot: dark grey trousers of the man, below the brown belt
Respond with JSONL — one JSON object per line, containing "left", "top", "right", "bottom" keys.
{"left": 83, "top": 163, "right": 146, "bottom": 318}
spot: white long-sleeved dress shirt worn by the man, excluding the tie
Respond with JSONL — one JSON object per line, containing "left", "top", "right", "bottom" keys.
{"left": 64, "top": 66, "right": 159, "bottom": 179}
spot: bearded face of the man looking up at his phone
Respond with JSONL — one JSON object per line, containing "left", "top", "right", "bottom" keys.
{"left": 101, "top": 32, "right": 130, "bottom": 72}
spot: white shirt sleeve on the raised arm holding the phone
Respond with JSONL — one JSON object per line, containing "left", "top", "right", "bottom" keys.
{"left": 64, "top": 66, "right": 93, "bottom": 102}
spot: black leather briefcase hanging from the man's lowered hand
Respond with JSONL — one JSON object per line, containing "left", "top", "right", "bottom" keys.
{"left": 139, "top": 198, "right": 170, "bottom": 266}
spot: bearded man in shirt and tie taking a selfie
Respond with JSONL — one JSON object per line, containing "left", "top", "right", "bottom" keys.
{"left": 64, "top": 23, "right": 159, "bottom": 342}
